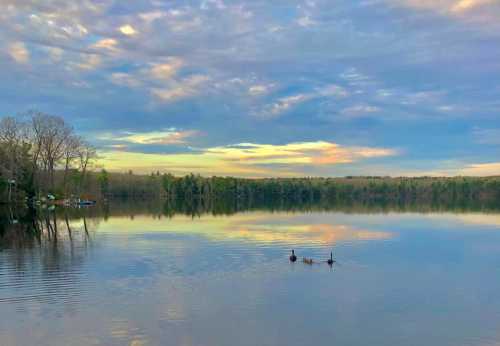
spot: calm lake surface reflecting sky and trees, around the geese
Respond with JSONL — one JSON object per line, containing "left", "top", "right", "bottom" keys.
{"left": 0, "top": 203, "right": 500, "bottom": 346}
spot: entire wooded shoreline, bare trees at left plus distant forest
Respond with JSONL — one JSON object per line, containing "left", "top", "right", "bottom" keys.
{"left": 0, "top": 112, "right": 500, "bottom": 207}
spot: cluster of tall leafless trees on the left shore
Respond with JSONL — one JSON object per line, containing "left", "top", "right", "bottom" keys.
{"left": 0, "top": 111, "right": 97, "bottom": 200}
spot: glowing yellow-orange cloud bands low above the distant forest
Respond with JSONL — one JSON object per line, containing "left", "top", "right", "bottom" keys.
{"left": 97, "top": 140, "right": 399, "bottom": 177}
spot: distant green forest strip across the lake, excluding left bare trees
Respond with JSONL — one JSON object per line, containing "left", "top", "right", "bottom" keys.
{"left": 90, "top": 170, "right": 500, "bottom": 208}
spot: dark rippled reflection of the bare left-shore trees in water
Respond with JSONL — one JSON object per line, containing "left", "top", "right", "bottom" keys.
{"left": 0, "top": 209, "right": 99, "bottom": 302}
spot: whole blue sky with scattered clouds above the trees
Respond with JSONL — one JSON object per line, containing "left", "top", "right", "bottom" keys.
{"left": 0, "top": 0, "right": 500, "bottom": 177}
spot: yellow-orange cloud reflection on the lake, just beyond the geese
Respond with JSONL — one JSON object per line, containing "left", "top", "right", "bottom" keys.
{"left": 100, "top": 213, "right": 392, "bottom": 245}
